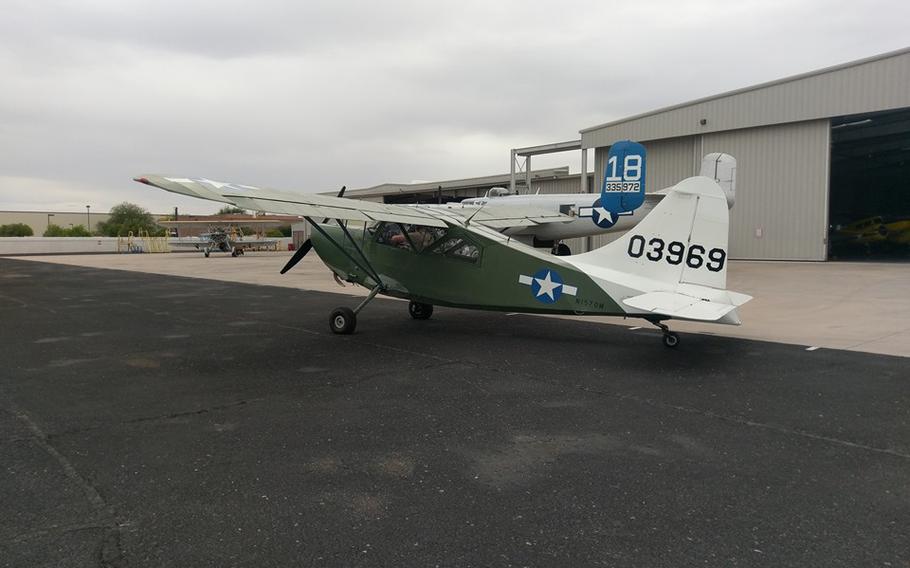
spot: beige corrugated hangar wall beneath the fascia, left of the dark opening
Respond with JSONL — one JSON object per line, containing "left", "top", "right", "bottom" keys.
{"left": 588, "top": 120, "right": 831, "bottom": 260}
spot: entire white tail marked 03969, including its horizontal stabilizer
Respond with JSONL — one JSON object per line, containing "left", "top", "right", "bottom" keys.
{"left": 568, "top": 176, "right": 751, "bottom": 324}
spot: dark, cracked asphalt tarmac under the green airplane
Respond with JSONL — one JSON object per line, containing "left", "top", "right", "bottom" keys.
{"left": 0, "top": 259, "right": 910, "bottom": 567}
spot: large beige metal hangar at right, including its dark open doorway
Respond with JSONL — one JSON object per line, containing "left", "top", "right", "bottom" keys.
{"left": 581, "top": 49, "right": 910, "bottom": 260}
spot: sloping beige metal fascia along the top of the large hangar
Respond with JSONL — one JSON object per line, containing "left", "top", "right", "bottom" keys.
{"left": 581, "top": 48, "right": 910, "bottom": 148}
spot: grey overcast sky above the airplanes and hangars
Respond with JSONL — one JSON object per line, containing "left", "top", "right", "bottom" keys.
{"left": 0, "top": 0, "right": 910, "bottom": 213}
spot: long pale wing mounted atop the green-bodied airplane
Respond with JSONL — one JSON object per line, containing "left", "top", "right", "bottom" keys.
{"left": 134, "top": 174, "right": 573, "bottom": 229}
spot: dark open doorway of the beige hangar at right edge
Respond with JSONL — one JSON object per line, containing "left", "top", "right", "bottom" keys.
{"left": 828, "top": 108, "right": 910, "bottom": 260}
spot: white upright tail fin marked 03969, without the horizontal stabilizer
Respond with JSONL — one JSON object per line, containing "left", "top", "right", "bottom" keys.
{"left": 569, "top": 176, "right": 729, "bottom": 293}
